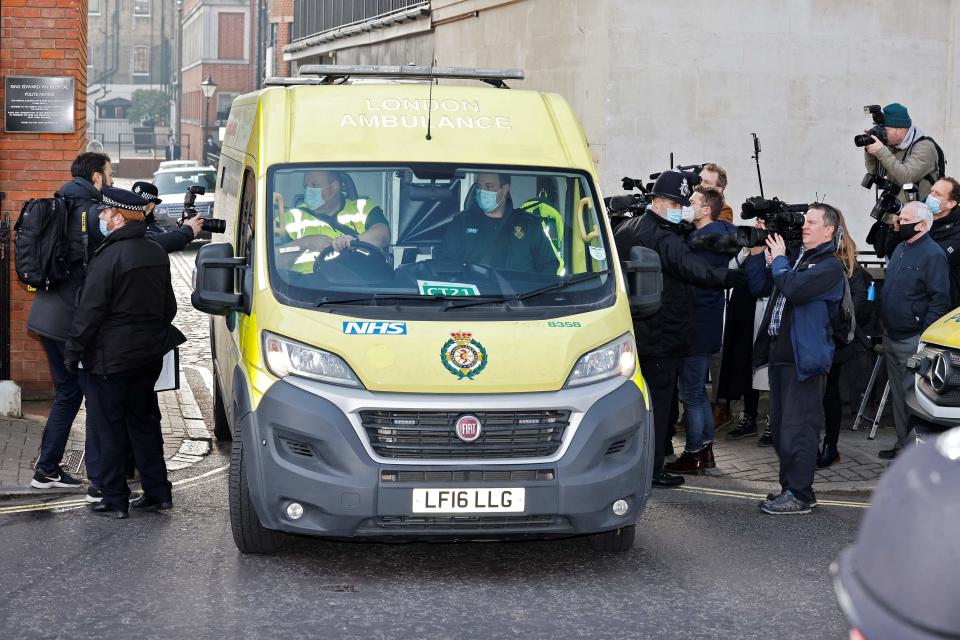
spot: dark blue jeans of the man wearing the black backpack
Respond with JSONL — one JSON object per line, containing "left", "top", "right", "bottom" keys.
{"left": 37, "top": 338, "right": 100, "bottom": 485}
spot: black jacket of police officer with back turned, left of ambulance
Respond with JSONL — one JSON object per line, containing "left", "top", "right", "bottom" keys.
{"left": 64, "top": 222, "right": 186, "bottom": 376}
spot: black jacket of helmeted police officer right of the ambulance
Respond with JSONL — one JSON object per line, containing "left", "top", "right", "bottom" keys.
{"left": 613, "top": 211, "right": 729, "bottom": 357}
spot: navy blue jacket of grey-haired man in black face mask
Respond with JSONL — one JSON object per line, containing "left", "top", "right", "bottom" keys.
{"left": 880, "top": 234, "right": 950, "bottom": 340}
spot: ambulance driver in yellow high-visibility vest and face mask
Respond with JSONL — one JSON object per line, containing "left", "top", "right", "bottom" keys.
{"left": 277, "top": 171, "right": 390, "bottom": 272}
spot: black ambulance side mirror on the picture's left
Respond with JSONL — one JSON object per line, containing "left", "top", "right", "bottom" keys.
{"left": 190, "top": 242, "right": 248, "bottom": 316}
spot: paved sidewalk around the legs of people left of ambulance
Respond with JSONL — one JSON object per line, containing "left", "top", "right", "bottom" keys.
{"left": 0, "top": 371, "right": 212, "bottom": 496}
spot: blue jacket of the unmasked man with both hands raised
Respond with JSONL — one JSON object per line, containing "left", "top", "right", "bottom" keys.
{"left": 746, "top": 242, "right": 846, "bottom": 381}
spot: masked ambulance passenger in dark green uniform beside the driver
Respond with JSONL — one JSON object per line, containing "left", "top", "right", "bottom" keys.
{"left": 438, "top": 173, "right": 560, "bottom": 275}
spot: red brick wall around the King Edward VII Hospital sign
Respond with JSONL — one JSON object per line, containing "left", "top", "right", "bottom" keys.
{"left": 0, "top": 0, "right": 87, "bottom": 398}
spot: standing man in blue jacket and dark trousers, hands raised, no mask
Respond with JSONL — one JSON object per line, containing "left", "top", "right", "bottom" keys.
{"left": 747, "top": 203, "right": 846, "bottom": 515}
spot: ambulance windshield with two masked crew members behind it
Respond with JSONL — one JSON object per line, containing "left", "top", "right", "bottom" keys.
{"left": 268, "top": 164, "right": 614, "bottom": 315}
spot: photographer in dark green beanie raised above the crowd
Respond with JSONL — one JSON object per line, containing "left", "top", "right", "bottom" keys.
{"left": 863, "top": 102, "right": 941, "bottom": 203}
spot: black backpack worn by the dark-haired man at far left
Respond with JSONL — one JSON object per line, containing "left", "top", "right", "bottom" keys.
{"left": 13, "top": 197, "right": 70, "bottom": 291}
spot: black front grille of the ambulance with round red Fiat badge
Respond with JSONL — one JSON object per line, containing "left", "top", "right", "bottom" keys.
{"left": 360, "top": 410, "right": 570, "bottom": 460}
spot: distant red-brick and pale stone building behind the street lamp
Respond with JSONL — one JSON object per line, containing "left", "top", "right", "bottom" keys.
{"left": 180, "top": 0, "right": 260, "bottom": 160}
